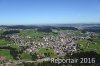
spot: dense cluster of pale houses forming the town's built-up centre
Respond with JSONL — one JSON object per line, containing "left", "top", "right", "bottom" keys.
{"left": 4, "top": 31, "right": 98, "bottom": 56}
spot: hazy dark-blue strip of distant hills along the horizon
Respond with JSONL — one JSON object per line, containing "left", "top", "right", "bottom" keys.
{"left": 0, "top": 24, "right": 100, "bottom": 32}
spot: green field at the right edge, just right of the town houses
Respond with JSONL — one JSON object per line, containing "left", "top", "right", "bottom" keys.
{"left": 77, "top": 38, "right": 100, "bottom": 54}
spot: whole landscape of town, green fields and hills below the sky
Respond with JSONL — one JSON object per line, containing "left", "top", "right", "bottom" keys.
{"left": 0, "top": 24, "right": 100, "bottom": 66}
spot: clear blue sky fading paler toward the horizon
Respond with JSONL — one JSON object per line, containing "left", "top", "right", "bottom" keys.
{"left": 0, "top": 0, "right": 100, "bottom": 25}
